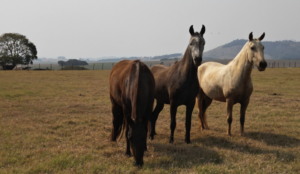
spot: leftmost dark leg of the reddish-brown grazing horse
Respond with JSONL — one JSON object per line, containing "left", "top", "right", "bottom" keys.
{"left": 111, "top": 98, "right": 124, "bottom": 141}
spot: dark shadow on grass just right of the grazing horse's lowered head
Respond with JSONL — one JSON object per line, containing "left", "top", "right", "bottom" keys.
{"left": 145, "top": 143, "right": 223, "bottom": 169}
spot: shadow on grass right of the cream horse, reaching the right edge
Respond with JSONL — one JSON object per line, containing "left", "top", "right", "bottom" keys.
{"left": 245, "top": 132, "right": 300, "bottom": 147}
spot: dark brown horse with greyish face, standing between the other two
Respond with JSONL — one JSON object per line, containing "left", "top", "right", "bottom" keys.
{"left": 150, "top": 25, "right": 205, "bottom": 144}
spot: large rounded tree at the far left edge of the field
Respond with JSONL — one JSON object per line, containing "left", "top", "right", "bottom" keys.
{"left": 0, "top": 33, "right": 38, "bottom": 66}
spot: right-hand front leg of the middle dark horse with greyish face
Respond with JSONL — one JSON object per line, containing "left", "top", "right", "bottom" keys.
{"left": 185, "top": 100, "right": 195, "bottom": 144}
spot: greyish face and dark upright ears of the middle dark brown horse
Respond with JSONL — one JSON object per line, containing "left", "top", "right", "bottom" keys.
{"left": 189, "top": 25, "right": 205, "bottom": 66}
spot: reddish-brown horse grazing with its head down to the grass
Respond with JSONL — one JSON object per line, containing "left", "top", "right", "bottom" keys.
{"left": 109, "top": 60, "right": 155, "bottom": 166}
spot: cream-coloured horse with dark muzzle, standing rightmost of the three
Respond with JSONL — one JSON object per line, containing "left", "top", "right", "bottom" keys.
{"left": 196, "top": 32, "right": 267, "bottom": 136}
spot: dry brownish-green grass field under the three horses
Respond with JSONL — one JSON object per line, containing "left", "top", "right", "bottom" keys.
{"left": 0, "top": 68, "right": 300, "bottom": 173}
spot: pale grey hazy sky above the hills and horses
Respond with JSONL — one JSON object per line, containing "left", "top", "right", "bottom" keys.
{"left": 0, "top": 0, "right": 300, "bottom": 58}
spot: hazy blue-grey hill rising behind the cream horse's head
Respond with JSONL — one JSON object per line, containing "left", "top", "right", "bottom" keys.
{"left": 203, "top": 39, "right": 300, "bottom": 59}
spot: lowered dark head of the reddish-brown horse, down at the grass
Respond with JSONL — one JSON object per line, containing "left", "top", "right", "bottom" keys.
{"left": 128, "top": 122, "right": 147, "bottom": 166}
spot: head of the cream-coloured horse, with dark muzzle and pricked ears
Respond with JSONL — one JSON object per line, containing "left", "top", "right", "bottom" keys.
{"left": 246, "top": 32, "right": 267, "bottom": 71}
